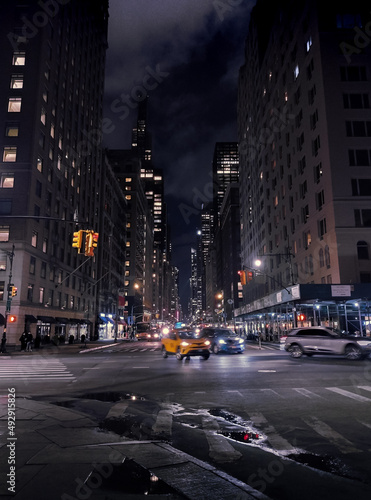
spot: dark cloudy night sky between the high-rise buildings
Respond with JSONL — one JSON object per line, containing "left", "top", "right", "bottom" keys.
{"left": 103, "top": 0, "right": 256, "bottom": 307}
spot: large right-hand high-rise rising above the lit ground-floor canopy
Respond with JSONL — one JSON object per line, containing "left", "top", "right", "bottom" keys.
{"left": 238, "top": 0, "right": 371, "bottom": 332}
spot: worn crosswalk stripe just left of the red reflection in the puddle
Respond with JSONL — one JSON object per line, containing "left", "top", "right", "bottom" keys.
{"left": 202, "top": 417, "right": 242, "bottom": 463}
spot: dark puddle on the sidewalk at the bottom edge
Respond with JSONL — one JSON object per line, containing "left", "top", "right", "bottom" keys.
{"left": 85, "top": 459, "right": 186, "bottom": 500}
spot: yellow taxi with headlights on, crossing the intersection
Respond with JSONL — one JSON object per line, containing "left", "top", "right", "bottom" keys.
{"left": 161, "top": 329, "right": 210, "bottom": 361}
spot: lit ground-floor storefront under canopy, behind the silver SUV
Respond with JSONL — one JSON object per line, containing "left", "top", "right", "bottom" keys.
{"left": 235, "top": 283, "right": 371, "bottom": 340}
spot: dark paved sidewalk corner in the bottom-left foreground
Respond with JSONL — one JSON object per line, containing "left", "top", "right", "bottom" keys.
{"left": 0, "top": 397, "right": 269, "bottom": 500}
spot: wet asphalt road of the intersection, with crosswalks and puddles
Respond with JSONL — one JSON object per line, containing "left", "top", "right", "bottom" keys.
{"left": 0, "top": 342, "right": 371, "bottom": 500}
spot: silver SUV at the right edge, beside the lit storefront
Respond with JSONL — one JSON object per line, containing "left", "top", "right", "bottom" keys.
{"left": 284, "top": 326, "right": 371, "bottom": 359}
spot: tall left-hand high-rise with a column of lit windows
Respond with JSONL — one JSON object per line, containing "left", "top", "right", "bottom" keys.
{"left": 0, "top": 0, "right": 108, "bottom": 343}
